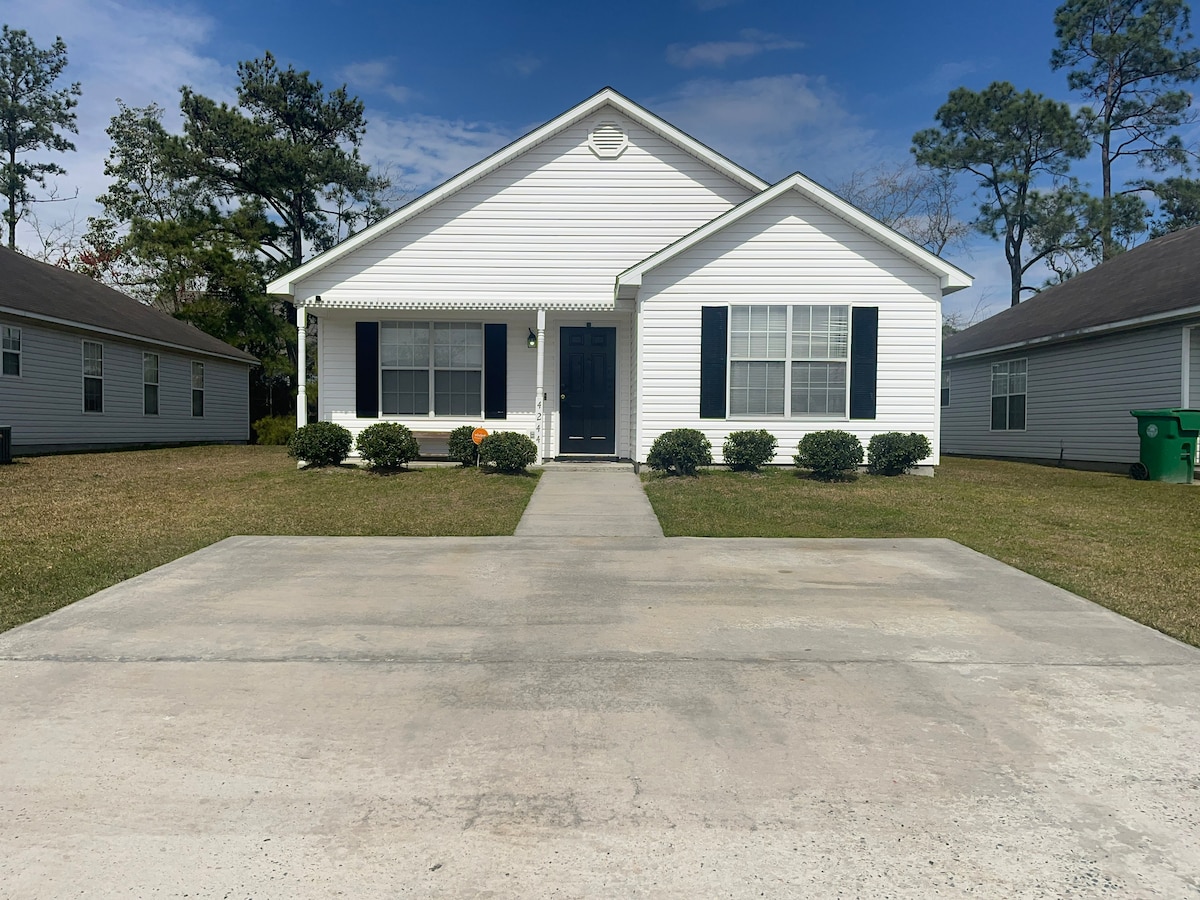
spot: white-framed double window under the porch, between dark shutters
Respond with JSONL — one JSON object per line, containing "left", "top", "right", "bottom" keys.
{"left": 379, "top": 322, "right": 484, "bottom": 415}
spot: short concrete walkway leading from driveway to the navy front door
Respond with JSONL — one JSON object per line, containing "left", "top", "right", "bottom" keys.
{"left": 516, "top": 463, "right": 662, "bottom": 538}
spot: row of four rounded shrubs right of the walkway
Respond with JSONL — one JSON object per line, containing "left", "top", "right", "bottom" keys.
{"left": 646, "top": 428, "right": 931, "bottom": 480}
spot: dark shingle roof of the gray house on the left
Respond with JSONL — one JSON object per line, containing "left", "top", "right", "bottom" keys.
{"left": 0, "top": 247, "right": 258, "bottom": 364}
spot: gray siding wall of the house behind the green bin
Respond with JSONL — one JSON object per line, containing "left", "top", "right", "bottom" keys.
{"left": 942, "top": 324, "right": 1194, "bottom": 463}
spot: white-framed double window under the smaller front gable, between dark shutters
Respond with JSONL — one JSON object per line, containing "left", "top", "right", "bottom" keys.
{"left": 730, "top": 306, "right": 850, "bottom": 418}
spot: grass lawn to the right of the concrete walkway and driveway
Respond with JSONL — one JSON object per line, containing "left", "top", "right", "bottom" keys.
{"left": 643, "top": 458, "right": 1200, "bottom": 646}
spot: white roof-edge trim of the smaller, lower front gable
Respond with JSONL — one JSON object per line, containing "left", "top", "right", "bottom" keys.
{"left": 617, "top": 172, "right": 972, "bottom": 298}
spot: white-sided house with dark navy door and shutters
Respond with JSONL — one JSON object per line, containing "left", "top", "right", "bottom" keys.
{"left": 269, "top": 88, "right": 971, "bottom": 466}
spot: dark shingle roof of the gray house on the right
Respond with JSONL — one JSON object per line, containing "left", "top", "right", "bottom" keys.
{"left": 942, "top": 226, "right": 1200, "bottom": 360}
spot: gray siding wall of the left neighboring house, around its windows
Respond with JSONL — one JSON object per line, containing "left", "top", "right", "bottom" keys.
{"left": 0, "top": 319, "right": 250, "bottom": 454}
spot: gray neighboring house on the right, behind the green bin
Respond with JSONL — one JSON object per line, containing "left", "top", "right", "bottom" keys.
{"left": 942, "top": 227, "right": 1200, "bottom": 467}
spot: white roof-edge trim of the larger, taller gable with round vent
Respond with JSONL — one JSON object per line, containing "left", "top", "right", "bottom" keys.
{"left": 266, "top": 88, "right": 767, "bottom": 294}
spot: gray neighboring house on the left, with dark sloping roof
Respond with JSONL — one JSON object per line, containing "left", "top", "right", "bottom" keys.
{"left": 0, "top": 248, "right": 257, "bottom": 455}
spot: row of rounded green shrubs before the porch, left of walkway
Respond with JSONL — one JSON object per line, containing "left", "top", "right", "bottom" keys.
{"left": 288, "top": 416, "right": 538, "bottom": 473}
